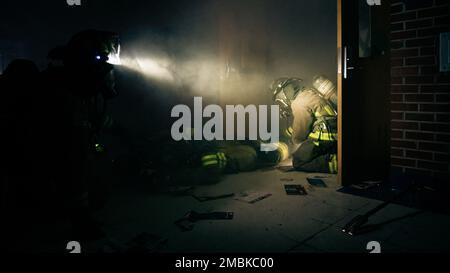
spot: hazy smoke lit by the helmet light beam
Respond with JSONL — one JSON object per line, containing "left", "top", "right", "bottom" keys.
{"left": 114, "top": 0, "right": 336, "bottom": 108}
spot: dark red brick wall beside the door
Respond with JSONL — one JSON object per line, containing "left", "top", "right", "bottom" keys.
{"left": 390, "top": 0, "right": 450, "bottom": 180}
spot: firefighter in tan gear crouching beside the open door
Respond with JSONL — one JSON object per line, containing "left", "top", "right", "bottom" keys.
{"left": 270, "top": 76, "right": 337, "bottom": 173}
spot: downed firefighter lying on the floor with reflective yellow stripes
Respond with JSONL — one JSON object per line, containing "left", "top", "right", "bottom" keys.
{"left": 141, "top": 133, "right": 289, "bottom": 187}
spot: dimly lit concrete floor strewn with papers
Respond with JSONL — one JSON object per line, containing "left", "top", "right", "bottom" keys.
{"left": 78, "top": 169, "right": 450, "bottom": 253}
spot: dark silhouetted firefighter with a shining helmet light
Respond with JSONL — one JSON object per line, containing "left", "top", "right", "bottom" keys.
{"left": 37, "top": 30, "right": 119, "bottom": 239}
